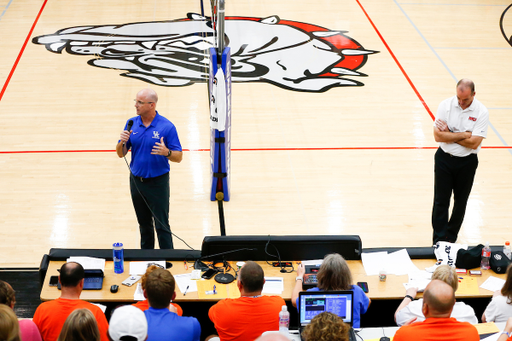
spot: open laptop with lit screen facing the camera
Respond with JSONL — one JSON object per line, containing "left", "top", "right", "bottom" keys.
{"left": 298, "top": 290, "right": 356, "bottom": 341}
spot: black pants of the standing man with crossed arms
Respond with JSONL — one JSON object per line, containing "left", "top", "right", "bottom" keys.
{"left": 432, "top": 148, "right": 478, "bottom": 245}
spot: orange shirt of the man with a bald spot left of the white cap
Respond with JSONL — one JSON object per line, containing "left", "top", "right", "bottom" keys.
{"left": 33, "top": 298, "right": 108, "bottom": 341}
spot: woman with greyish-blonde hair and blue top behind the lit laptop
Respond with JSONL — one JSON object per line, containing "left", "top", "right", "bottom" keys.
{"left": 292, "top": 253, "right": 371, "bottom": 328}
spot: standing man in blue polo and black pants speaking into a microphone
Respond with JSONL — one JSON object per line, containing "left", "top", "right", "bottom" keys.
{"left": 116, "top": 89, "right": 183, "bottom": 249}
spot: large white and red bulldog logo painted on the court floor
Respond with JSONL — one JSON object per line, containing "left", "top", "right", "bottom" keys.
{"left": 32, "top": 13, "right": 378, "bottom": 92}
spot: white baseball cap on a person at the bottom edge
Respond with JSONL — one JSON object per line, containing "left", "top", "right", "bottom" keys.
{"left": 108, "top": 305, "right": 148, "bottom": 341}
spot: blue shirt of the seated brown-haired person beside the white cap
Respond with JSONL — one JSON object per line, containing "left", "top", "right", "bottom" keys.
{"left": 144, "top": 307, "right": 201, "bottom": 341}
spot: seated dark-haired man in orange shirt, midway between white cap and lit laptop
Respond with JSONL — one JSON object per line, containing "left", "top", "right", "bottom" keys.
{"left": 208, "top": 261, "right": 286, "bottom": 341}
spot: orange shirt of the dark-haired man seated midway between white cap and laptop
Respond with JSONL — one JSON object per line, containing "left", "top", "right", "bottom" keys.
{"left": 208, "top": 296, "right": 286, "bottom": 341}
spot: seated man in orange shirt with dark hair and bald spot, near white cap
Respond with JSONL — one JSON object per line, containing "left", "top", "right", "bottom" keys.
{"left": 33, "top": 262, "right": 108, "bottom": 341}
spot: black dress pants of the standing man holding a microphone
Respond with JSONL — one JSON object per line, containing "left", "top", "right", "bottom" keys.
{"left": 130, "top": 173, "right": 174, "bottom": 249}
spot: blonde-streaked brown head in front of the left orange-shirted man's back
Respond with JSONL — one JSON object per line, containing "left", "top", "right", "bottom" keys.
{"left": 57, "top": 308, "right": 100, "bottom": 341}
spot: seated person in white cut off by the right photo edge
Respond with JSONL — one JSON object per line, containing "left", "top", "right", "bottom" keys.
{"left": 482, "top": 264, "right": 512, "bottom": 323}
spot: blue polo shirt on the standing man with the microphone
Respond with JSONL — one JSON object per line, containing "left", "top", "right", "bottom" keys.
{"left": 124, "top": 112, "right": 182, "bottom": 178}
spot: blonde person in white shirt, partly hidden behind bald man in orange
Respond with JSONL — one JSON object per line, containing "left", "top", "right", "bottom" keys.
{"left": 395, "top": 265, "right": 478, "bottom": 326}
